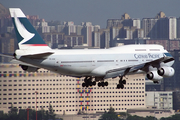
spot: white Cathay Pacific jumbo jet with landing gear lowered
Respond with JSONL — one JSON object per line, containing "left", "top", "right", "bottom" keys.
{"left": 0, "top": 8, "right": 175, "bottom": 89}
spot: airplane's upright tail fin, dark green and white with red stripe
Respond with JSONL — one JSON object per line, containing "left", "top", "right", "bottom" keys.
{"left": 9, "top": 8, "right": 50, "bottom": 49}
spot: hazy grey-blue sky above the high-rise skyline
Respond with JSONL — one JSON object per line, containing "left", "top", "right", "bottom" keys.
{"left": 0, "top": 0, "right": 180, "bottom": 28}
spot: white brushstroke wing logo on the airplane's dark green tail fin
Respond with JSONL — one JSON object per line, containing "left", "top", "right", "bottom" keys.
{"left": 14, "top": 13, "right": 35, "bottom": 45}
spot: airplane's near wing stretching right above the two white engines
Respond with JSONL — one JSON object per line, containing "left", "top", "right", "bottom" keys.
{"left": 104, "top": 57, "right": 174, "bottom": 78}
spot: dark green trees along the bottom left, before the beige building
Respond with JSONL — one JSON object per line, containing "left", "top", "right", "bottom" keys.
{"left": 0, "top": 104, "right": 63, "bottom": 120}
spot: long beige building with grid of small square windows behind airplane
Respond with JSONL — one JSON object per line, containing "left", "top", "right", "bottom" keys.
{"left": 0, "top": 64, "right": 146, "bottom": 115}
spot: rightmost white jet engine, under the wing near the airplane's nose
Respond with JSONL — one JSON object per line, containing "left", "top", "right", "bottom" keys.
{"left": 158, "top": 67, "right": 175, "bottom": 77}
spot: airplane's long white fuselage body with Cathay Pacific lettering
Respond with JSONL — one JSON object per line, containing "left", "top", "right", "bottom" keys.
{"left": 17, "top": 45, "right": 173, "bottom": 77}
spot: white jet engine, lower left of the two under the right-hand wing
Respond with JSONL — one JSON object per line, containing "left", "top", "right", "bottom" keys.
{"left": 146, "top": 71, "right": 163, "bottom": 81}
